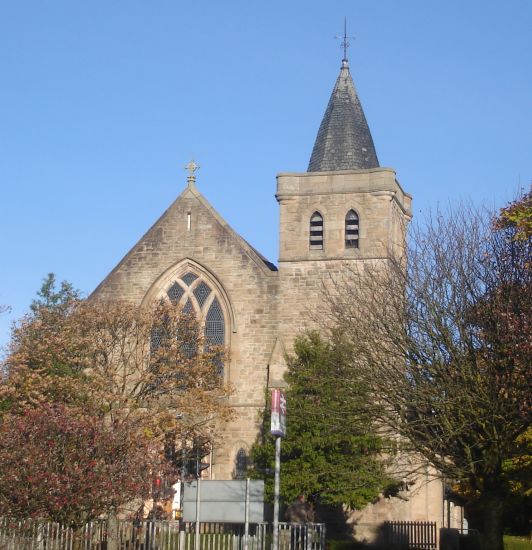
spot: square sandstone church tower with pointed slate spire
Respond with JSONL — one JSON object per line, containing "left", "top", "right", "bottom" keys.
{"left": 270, "top": 51, "right": 411, "bottom": 366}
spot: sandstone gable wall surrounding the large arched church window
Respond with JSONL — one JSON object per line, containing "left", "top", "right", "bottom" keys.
{"left": 93, "top": 186, "right": 278, "bottom": 479}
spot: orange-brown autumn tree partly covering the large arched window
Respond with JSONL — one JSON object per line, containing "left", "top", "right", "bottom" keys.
{"left": 0, "top": 301, "right": 230, "bottom": 441}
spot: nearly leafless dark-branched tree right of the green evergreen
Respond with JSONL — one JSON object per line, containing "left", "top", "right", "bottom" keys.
{"left": 328, "top": 207, "right": 532, "bottom": 550}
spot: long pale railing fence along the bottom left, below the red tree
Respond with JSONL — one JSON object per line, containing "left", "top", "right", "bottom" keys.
{"left": 0, "top": 518, "right": 325, "bottom": 550}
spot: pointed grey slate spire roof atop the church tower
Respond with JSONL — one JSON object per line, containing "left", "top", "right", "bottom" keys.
{"left": 307, "top": 58, "right": 379, "bottom": 172}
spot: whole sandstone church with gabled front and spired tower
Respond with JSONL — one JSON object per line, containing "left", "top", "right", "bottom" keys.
{"left": 94, "top": 54, "right": 458, "bottom": 528}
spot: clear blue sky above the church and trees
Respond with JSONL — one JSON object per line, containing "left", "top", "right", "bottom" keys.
{"left": 0, "top": 0, "right": 532, "bottom": 352}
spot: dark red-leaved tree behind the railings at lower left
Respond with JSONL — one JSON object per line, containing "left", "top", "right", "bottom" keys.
{"left": 0, "top": 405, "right": 158, "bottom": 528}
